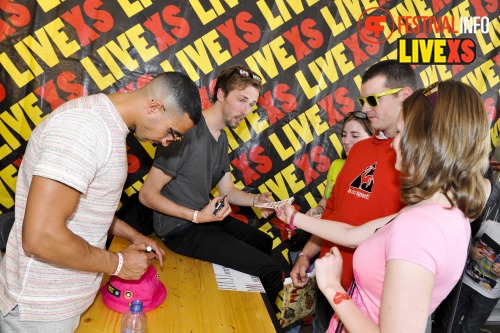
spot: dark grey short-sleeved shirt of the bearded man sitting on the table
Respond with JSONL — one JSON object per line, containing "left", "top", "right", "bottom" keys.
{"left": 153, "top": 116, "right": 230, "bottom": 237}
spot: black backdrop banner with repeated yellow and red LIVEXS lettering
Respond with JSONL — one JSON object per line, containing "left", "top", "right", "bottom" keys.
{"left": 0, "top": 0, "right": 500, "bottom": 314}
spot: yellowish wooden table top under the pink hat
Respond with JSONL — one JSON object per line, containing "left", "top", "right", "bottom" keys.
{"left": 76, "top": 236, "right": 280, "bottom": 333}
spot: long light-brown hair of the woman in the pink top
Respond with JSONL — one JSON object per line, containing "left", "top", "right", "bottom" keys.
{"left": 400, "top": 80, "right": 489, "bottom": 219}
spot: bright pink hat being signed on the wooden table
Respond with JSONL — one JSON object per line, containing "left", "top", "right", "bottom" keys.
{"left": 101, "top": 265, "right": 167, "bottom": 313}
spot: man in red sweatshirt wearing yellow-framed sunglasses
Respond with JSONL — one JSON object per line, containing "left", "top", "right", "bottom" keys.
{"left": 290, "top": 60, "right": 417, "bottom": 333}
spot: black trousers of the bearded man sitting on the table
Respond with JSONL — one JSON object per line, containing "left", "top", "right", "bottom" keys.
{"left": 162, "top": 216, "right": 283, "bottom": 308}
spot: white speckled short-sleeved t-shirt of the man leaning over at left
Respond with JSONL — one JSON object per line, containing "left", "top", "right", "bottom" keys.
{"left": 0, "top": 94, "right": 129, "bottom": 321}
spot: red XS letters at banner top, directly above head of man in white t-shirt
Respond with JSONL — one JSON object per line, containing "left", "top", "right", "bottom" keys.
{"left": 144, "top": 6, "right": 190, "bottom": 52}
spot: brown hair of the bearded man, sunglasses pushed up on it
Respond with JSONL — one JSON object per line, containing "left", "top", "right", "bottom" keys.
{"left": 212, "top": 65, "right": 262, "bottom": 103}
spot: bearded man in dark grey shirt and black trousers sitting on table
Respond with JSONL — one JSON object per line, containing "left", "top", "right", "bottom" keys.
{"left": 139, "top": 65, "right": 282, "bottom": 305}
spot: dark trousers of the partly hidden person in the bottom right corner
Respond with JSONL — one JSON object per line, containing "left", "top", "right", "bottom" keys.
{"left": 435, "top": 283, "right": 498, "bottom": 333}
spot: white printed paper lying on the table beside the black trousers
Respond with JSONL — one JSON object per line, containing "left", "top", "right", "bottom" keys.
{"left": 212, "top": 263, "right": 266, "bottom": 293}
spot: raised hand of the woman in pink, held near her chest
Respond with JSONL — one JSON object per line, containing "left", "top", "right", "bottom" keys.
{"left": 314, "top": 247, "right": 342, "bottom": 293}
